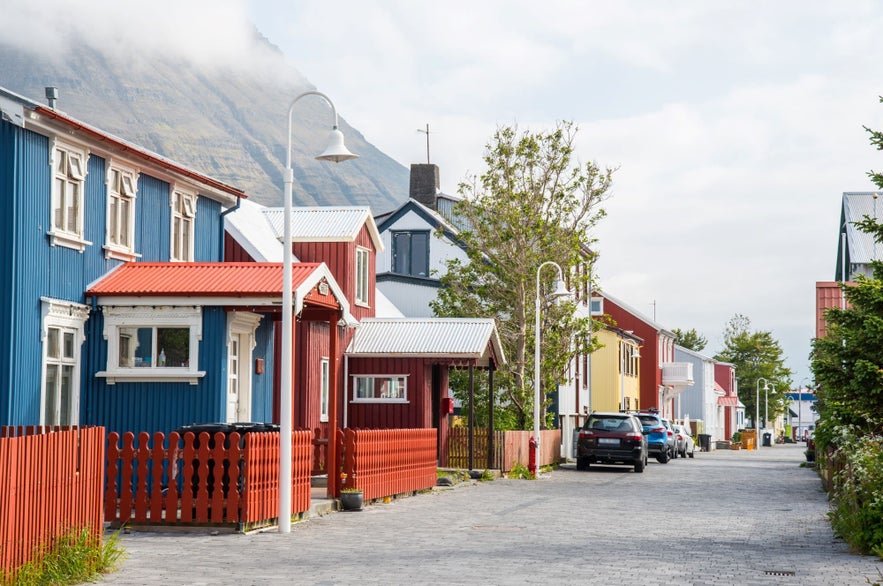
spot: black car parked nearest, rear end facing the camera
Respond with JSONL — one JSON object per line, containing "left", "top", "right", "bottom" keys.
{"left": 576, "top": 411, "right": 648, "bottom": 472}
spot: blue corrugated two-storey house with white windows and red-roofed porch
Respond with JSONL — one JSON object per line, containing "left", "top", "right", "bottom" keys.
{"left": 0, "top": 88, "right": 348, "bottom": 432}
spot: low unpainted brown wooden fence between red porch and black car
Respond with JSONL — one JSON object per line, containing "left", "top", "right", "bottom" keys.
{"left": 442, "top": 427, "right": 561, "bottom": 473}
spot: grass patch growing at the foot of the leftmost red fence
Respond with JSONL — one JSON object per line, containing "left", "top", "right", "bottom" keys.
{"left": 0, "top": 528, "right": 125, "bottom": 586}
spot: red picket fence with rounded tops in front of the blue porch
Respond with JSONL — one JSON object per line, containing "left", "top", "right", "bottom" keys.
{"left": 104, "top": 431, "right": 312, "bottom": 529}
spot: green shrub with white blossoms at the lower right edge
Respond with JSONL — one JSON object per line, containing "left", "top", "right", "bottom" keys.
{"left": 826, "top": 434, "right": 883, "bottom": 558}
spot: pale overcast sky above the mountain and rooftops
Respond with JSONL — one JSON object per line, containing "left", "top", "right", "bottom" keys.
{"left": 0, "top": 0, "right": 883, "bottom": 384}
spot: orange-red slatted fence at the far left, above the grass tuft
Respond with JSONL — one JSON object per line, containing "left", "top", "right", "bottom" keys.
{"left": 0, "top": 427, "right": 104, "bottom": 583}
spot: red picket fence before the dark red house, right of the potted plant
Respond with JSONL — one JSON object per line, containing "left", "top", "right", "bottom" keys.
{"left": 341, "top": 429, "right": 437, "bottom": 500}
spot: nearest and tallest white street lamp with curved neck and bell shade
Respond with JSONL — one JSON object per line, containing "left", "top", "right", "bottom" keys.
{"left": 279, "top": 91, "right": 358, "bottom": 533}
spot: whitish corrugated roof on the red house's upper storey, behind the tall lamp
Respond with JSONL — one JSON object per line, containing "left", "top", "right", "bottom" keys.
{"left": 264, "top": 206, "right": 383, "bottom": 249}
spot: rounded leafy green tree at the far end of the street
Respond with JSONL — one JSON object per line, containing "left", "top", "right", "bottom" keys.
{"left": 714, "top": 314, "right": 791, "bottom": 421}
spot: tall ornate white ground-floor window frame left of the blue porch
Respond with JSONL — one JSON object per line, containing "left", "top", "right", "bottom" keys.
{"left": 40, "top": 297, "right": 89, "bottom": 425}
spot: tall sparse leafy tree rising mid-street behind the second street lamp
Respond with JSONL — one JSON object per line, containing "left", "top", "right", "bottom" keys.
{"left": 432, "top": 122, "right": 614, "bottom": 429}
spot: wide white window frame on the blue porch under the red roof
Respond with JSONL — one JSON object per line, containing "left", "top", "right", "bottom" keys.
{"left": 95, "top": 306, "right": 205, "bottom": 385}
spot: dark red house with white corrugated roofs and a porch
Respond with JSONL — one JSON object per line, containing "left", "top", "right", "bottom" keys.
{"left": 224, "top": 202, "right": 504, "bottom": 468}
